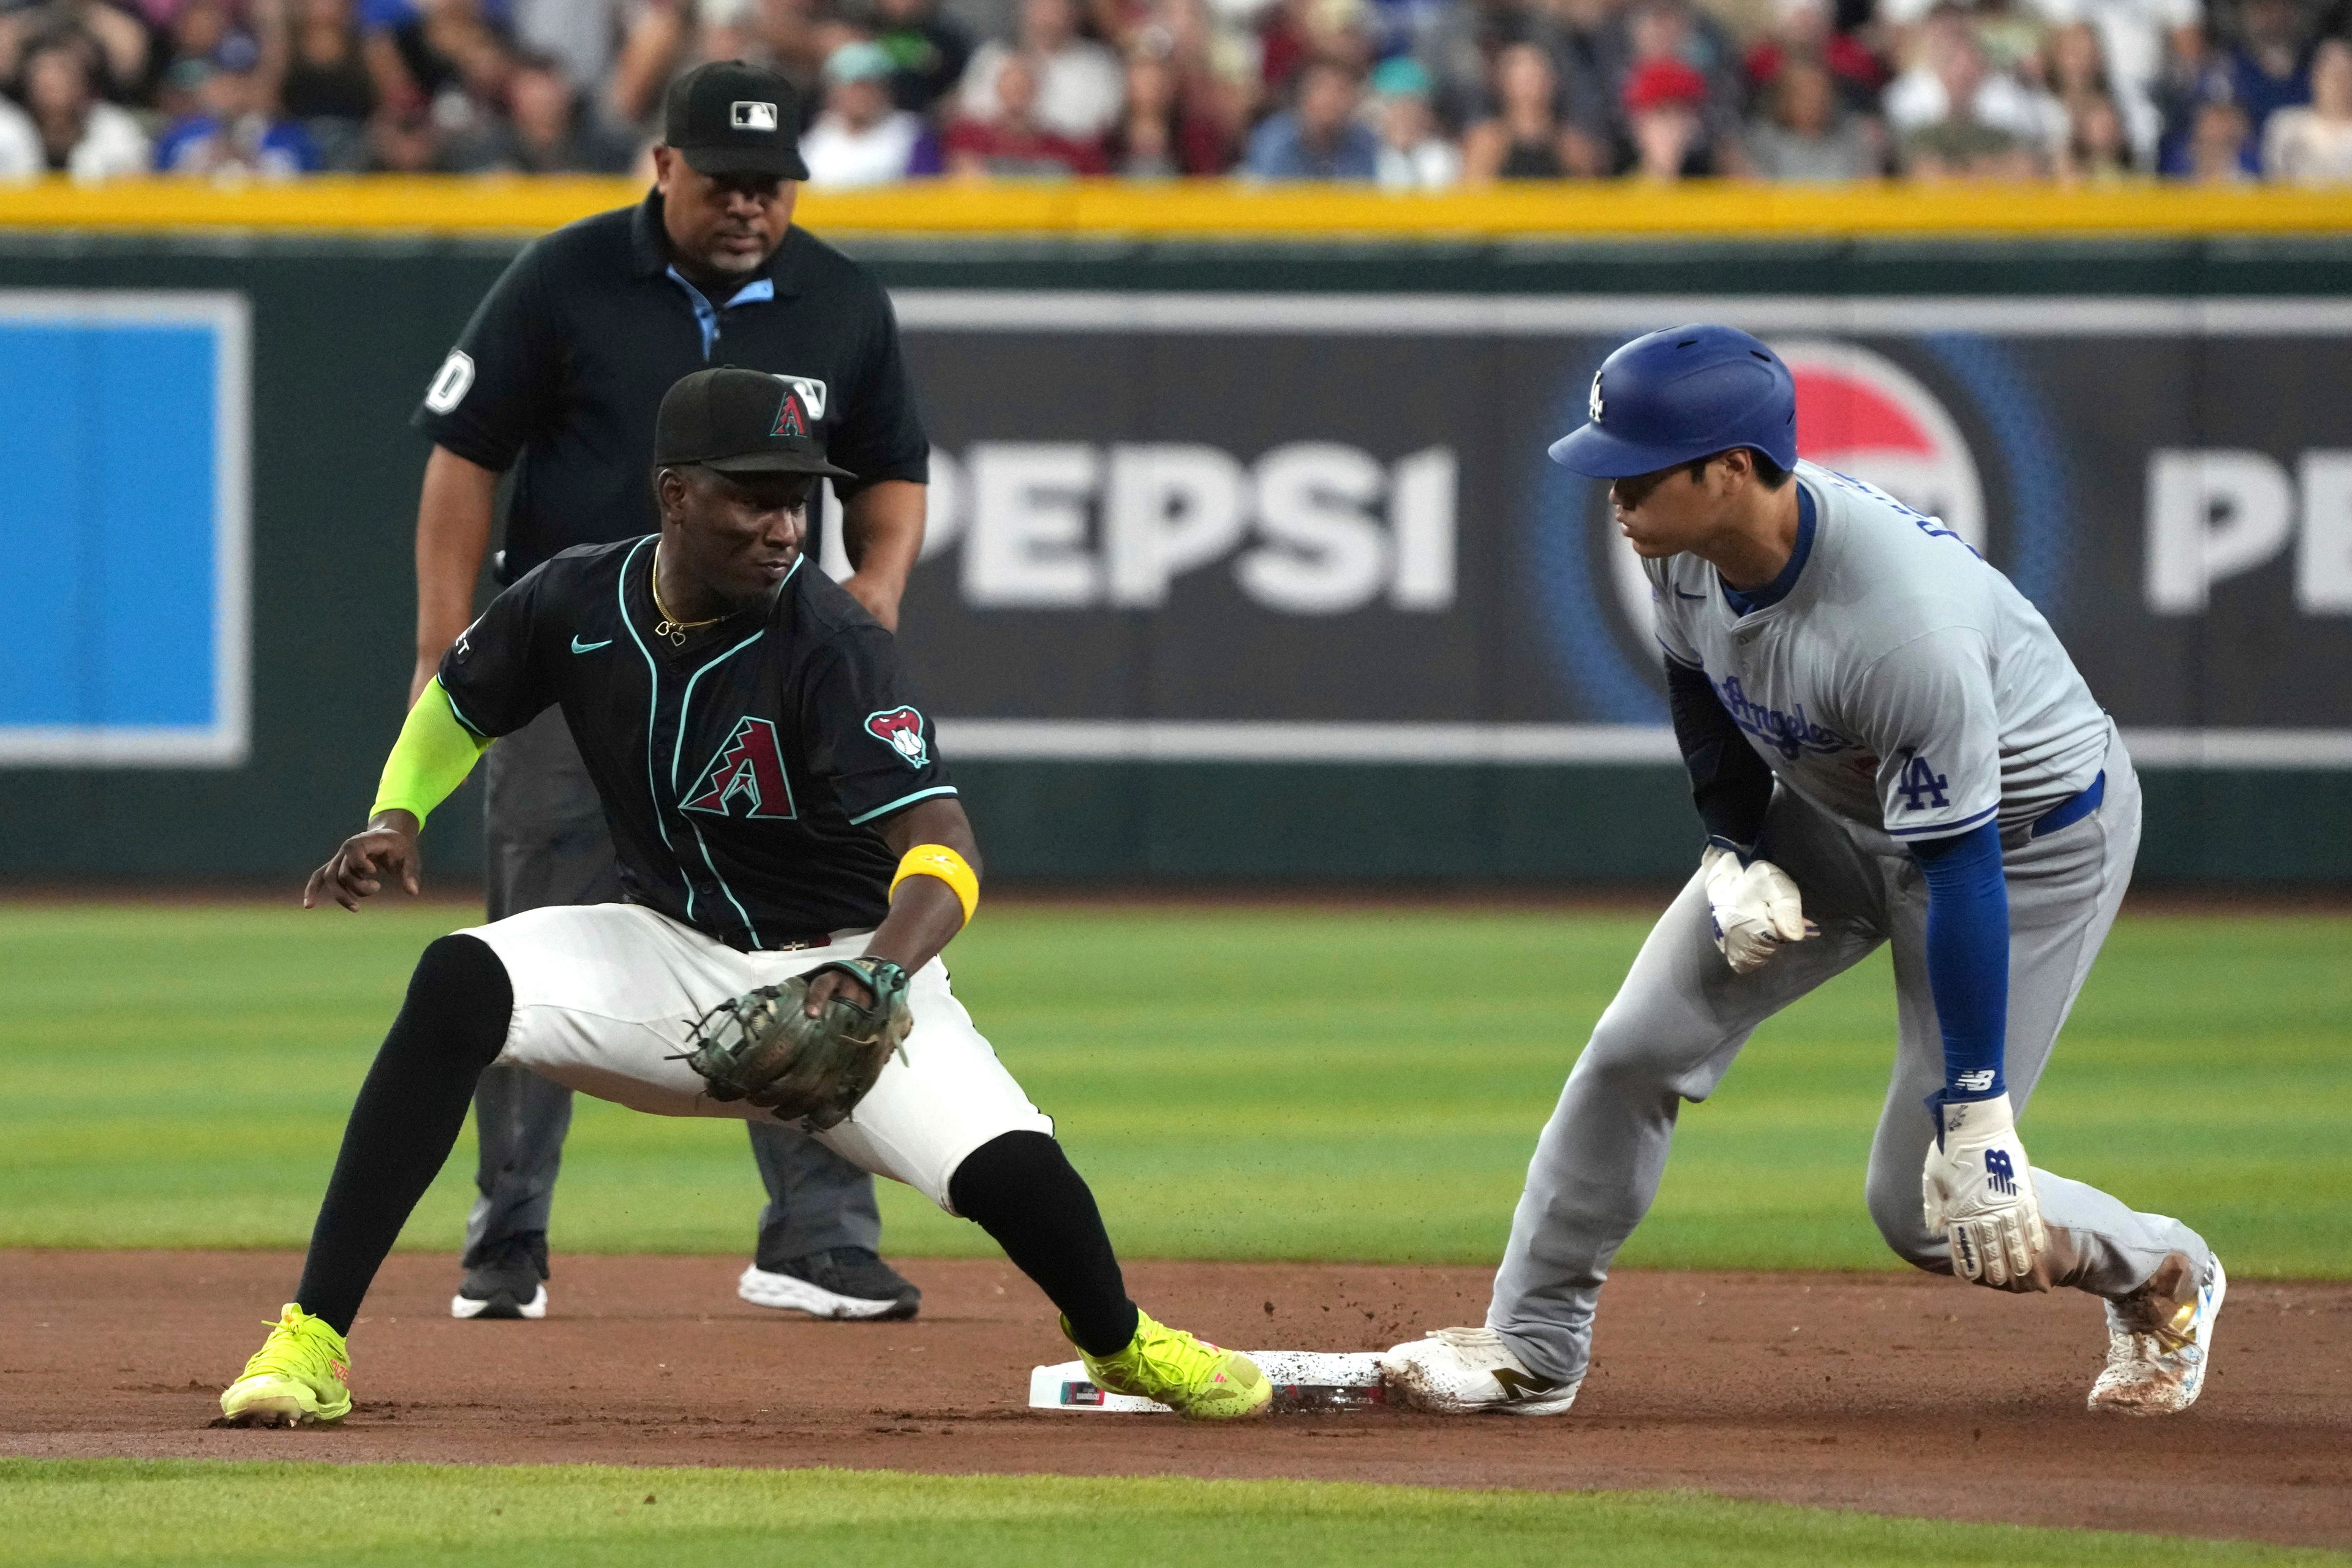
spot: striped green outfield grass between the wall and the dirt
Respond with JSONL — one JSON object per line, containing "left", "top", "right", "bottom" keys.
{"left": 0, "top": 905, "right": 2352, "bottom": 1276}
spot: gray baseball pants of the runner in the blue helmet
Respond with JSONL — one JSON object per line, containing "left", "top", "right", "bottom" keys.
{"left": 1487, "top": 741, "right": 2209, "bottom": 1380}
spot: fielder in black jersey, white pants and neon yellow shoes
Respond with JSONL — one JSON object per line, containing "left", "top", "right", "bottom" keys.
{"left": 221, "top": 367, "right": 1272, "bottom": 1425}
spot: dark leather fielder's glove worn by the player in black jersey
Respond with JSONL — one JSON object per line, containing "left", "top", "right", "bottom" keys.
{"left": 670, "top": 959, "right": 915, "bottom": 1133}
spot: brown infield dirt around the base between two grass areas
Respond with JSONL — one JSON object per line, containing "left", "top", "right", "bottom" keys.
{"left": 0, "top": 1251, "right": 2352, "bottom": 1547}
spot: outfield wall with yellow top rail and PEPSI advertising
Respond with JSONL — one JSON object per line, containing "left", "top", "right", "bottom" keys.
{"left": 0, "top": 181, "right": 2352, "bottom": 881}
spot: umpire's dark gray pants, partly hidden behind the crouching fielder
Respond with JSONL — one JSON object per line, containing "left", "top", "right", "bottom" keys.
{"left": 466, "top": 710, "right": 882, "bottom": 1270}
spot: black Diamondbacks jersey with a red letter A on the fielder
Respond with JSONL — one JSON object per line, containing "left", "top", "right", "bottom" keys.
{"left": 440, "top": 536, "right": 955, "bottom": 952}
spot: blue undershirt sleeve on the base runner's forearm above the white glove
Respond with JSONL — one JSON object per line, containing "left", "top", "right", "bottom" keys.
{"left": 1910, "top": 823, "right": 2008, "bottom": 1100}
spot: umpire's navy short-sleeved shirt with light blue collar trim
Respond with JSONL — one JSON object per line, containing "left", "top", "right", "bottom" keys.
{"left": 414, "top": 190, "right": 932, "bottom": 583}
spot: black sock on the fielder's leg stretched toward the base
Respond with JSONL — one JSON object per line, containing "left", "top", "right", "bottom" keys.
{"left": 948, "top": 1133, "right": 1136, "bottom": 1357}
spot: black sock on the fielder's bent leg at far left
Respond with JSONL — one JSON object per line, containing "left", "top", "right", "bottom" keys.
{"left": 294, "top": 936, "right": 515, "bottom": 1333}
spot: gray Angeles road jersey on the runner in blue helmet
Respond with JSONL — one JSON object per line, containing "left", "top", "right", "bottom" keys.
{"left": 1642, "top": 461, "right": 2108, "bottom": 842}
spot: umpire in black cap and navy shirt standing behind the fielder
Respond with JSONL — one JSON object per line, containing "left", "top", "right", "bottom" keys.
{"left": 409, "top": 61, "right": 929, "bottom": 1319}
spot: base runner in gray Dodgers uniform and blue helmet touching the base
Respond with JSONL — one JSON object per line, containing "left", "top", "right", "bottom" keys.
{"left": 1383, "top": 326, "right": 2227, "bottom": 1415}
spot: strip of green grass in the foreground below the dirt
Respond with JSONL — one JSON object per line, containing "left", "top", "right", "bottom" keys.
{"left": 13, "top": 1460, "right": 2352, "bottom": 1568}
